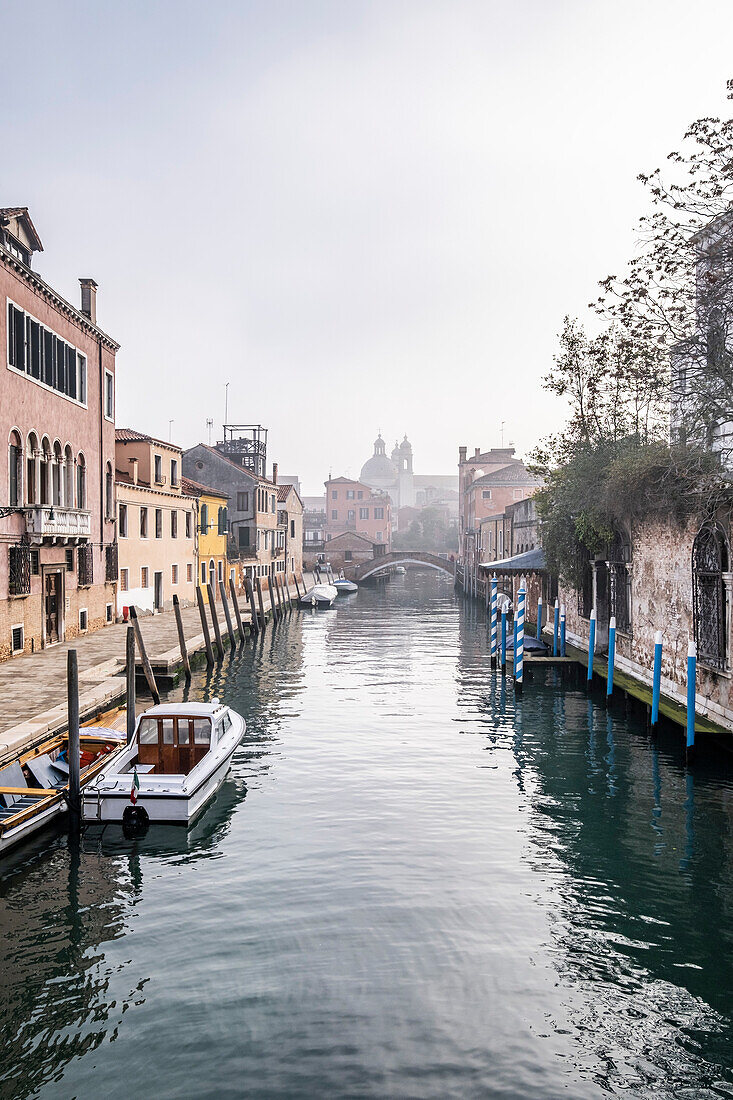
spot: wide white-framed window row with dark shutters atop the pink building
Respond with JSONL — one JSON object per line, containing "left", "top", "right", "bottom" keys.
{"left": 8, "top": 301, "right": 87, "bottom": 405}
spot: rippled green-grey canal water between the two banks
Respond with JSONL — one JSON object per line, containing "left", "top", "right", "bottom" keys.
{"left": 0, "top": 573, "right": 733, "bottom": 1100}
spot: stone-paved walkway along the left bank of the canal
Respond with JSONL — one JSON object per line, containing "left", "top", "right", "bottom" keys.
{"left": 0, "top": 576, "right": 311, "bottom": 763}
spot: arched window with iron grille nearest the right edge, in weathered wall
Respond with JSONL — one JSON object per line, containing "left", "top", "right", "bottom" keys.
{"left": 692, "top": 523, "right": 730, "bottom": 669}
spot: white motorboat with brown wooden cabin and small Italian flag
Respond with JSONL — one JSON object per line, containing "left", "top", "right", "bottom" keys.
{"left": 84, "top": 699, "right": 245, "bottom": 827}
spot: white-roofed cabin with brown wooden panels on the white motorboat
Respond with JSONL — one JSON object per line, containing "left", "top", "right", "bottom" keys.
{"left": 138, "top": 704, "right": 231, "bottom": 776}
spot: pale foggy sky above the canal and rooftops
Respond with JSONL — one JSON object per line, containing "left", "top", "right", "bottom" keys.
{"left": 5, "top": 0, "right": 733, "bottom": 493}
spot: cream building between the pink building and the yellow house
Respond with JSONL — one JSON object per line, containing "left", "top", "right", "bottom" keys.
{"left": 116, "top": 428, "right": 197, "bottom": 614}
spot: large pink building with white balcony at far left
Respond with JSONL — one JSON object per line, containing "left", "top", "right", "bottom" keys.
{"left": 0, "top": 207, "right": 119, "bottom": 659}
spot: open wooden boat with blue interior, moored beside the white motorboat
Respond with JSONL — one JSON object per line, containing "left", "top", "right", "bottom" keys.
{"left": 0, "top": 726, "right": 124, "bottom": 855}
